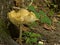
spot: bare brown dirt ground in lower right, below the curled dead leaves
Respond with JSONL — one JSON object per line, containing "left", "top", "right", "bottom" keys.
{"left": 33, "top": 23, "right": 60, "bottom": 45}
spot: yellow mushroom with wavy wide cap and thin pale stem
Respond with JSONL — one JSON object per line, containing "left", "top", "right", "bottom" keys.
{"left": 7, "top": 8, "right": 38, "bottom": 43}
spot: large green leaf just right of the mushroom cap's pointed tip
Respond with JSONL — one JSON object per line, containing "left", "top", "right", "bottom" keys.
{"left": 39, "top": 10, "right": 51, "bottom": 25}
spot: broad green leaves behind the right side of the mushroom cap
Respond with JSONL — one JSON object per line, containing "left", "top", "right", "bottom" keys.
{"left": 28, "top": 6, "right": 53, "bottom": 25}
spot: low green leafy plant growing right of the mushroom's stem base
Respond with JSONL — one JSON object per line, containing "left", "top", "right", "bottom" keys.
{"left": 23, "top": 32, "right": 41, "bottom": 45}
